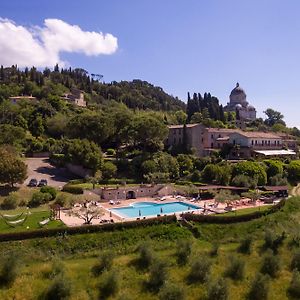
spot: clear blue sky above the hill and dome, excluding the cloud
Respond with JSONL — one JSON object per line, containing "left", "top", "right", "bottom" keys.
{"left": 0, "top": 0, "right": 300, "bottom": 126}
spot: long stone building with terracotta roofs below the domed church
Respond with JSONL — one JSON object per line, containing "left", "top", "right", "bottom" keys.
{"left": 165, "top": 124, "right": 297, "bottom": 159}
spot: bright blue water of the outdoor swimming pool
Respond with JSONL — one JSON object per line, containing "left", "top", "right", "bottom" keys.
{"left": 110, "top": 202, "right": 201, "bottom": 218}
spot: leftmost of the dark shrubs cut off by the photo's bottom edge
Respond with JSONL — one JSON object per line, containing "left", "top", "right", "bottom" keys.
{"left": 43, "top": 274, "right": 71, "bottom": 300}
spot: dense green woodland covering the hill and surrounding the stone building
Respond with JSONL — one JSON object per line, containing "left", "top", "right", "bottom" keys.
{"left": 0, "top": 66, "right": 300, "bottom": 186}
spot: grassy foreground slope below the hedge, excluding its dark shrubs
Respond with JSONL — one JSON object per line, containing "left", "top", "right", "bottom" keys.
{"left": 0, "top": 198, "right": 300, "bottom": 300}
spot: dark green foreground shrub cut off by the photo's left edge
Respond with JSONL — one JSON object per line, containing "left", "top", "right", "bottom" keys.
{"left": 0, "top": 254, "right": 19, "bottom": 286}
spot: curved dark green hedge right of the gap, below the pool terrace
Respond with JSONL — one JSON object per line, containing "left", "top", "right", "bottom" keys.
{"left": 182, "top": 200, "right": 285, "bottom": 224}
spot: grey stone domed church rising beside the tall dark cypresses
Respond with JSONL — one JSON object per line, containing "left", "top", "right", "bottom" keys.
{"left": 224, "top": 83, "right": 256, "bottom": 121}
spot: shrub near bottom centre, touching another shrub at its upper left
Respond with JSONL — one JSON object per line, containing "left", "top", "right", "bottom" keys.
{"left": 147, "top": 260, "right": 167, "bottom": 292}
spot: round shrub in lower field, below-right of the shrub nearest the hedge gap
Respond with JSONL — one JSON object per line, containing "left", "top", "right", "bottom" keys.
{"left": 188, "top": 257, "right": 211, "bottom": 283}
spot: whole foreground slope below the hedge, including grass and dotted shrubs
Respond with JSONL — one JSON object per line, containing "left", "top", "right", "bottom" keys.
{"left": 0, "top": 198, "right": 300, "bottom": 300}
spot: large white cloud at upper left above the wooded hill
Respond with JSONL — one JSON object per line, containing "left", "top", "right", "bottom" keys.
{"left": 0, "top": 18, "right": 118, "bottom": 67}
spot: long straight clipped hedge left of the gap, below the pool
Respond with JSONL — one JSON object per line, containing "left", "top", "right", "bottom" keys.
{"left": 0, "top": 215, "right": 177, "bottom": 242}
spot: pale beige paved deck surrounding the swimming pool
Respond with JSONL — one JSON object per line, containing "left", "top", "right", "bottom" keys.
{"left": 61, "top": 196, "right": 272, "bottom": 226}
